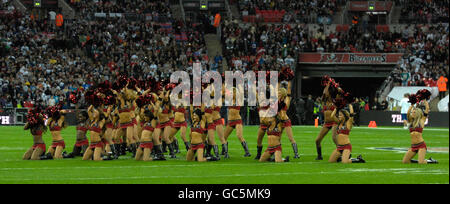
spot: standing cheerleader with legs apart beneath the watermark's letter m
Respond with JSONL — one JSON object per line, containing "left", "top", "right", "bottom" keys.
{"left": 224, "top": 88, "right": 251, "bottom": 157}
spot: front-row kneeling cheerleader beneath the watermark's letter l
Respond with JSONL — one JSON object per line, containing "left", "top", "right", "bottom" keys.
{"left": 186, "top": 106, "right": 207, "bottom": 162}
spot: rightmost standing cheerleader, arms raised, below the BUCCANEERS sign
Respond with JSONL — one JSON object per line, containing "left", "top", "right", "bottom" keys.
{"left": 316, "top": 82, "right": 337, "bottom": 160}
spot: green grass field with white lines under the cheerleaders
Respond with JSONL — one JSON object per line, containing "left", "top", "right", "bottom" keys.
{"left": 0, "top": 126, "right": 449, "bottom": 184}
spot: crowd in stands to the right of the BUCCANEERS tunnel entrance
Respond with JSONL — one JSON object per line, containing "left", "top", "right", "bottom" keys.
{"left": 386, "top": 24, "right": 449, "bottom": 87}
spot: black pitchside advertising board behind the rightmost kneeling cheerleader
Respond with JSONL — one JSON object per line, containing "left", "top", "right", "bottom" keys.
{"left": 360, "top": 111, "right": 449, "bottom": 128}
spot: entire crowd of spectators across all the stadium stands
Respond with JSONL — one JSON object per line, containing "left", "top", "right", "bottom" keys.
{"left": 0, "top": 0, "right": 449, "bottom": 115}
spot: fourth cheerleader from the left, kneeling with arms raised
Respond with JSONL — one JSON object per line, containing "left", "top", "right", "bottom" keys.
{"left": 83, "top": 105, "right": 105, "bottom": 161}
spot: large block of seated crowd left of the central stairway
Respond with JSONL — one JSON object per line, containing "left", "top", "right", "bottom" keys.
{"left": 0, "top": 3, "right": 209, "bottom": 108}
